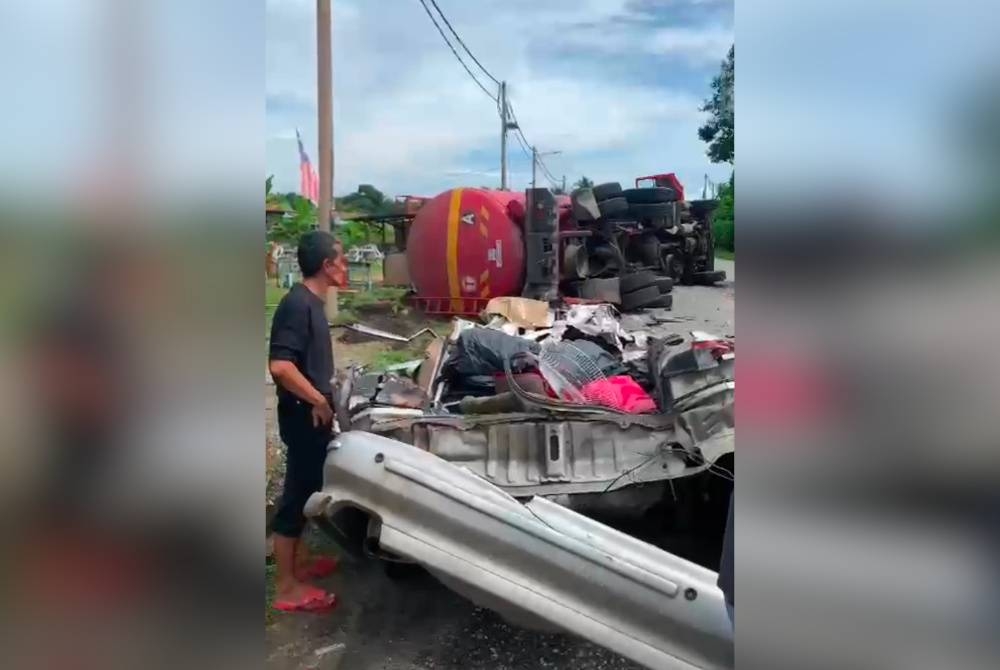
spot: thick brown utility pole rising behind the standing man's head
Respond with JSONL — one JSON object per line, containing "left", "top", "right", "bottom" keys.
{"left": 316, "top": 0, "right": 333, "bottom": 231}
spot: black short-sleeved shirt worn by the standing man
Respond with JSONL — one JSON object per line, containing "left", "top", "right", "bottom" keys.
{"left": 268, "top": 284, "right": 333, "bottom": 403}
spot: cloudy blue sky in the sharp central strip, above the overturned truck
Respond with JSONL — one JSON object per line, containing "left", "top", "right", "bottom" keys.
{"left": 266, "top": 0, "right": 733, "bottom": 200}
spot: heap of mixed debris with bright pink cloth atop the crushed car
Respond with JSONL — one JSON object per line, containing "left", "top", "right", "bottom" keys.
{"left": 336, "top": 298, "right": 735, "bottom": 440}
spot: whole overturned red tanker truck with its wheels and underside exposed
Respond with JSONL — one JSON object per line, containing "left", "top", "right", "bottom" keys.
{"left": 363, "top": 173, "right": 726, "bottom": 315}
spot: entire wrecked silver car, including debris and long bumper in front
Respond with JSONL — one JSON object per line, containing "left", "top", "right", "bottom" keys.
{"left": 306, "top": 298, "right": 735, "bottom": 668}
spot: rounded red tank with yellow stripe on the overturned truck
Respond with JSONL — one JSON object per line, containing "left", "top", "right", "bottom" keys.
{"left": 406, "top": 188, "right": 569, "bottom": 299}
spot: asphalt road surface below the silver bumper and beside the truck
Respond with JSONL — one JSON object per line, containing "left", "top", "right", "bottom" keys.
{"left": 266, "top": 260, "right": 735, "bottom": 670}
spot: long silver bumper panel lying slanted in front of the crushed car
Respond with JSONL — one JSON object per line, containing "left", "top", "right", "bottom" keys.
{"left": 305, "top": 432, "right": 733, "bottom": 670}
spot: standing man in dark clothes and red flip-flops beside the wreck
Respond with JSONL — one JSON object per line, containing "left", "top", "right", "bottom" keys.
{"left": 268, "top": 231, "right": 337, "bottom": 612}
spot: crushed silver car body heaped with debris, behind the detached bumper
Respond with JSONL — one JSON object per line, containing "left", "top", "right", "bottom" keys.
{"left": 338, "top": 305, "right": 735, "bottom": 515}
